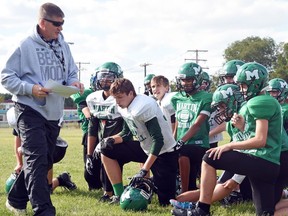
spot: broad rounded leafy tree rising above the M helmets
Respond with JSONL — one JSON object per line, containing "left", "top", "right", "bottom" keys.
{"left": 224, "top": 36, "right": 278, "bottom": 70}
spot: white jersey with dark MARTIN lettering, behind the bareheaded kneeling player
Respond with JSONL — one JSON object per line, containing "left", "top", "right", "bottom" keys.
{"left": 86, "top": 90, "right": 121, "bottom": 119}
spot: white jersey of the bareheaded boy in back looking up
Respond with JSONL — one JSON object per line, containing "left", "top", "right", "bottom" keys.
{"left": 157, "top": 92, "right": 177, "bottom": 131}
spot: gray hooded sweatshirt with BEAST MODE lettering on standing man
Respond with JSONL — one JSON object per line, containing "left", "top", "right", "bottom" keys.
{"left": 1, "top": 26, "right": 78, "bottom": 120}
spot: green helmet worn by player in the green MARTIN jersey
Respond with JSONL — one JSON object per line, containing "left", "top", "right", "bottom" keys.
{"left": 176, "top": 62, "right": 202, "bottom": 94}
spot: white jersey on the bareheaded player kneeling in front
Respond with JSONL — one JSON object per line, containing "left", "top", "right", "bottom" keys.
{"left": 118, "top": 95, "right": 176, "bottom": 155}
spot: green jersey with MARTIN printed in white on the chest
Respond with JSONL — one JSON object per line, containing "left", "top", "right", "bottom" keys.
{"left": 171, "top": 91, "right": 212, "bottom": 148}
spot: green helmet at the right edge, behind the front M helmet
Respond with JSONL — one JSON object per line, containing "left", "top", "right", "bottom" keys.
{"left": 267, "top": 78, "right": 288, "bottom": 102}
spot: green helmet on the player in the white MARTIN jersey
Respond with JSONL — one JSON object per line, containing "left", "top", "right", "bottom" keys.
{"left": 92, "top": 62, "right": 123, "bottom": 91}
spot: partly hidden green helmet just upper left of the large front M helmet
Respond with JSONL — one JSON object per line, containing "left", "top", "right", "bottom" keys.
{"left": 219, "top": 60, "right": 245, "bottom": 84}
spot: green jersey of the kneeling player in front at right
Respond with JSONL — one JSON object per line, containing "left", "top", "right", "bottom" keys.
{"left": 239, "top": 95, "right": 282, "bottom": 164}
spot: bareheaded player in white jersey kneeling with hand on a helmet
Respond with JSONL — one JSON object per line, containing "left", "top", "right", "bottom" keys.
{"left": 100, "top": 78, "right": 178, "bottom": 206}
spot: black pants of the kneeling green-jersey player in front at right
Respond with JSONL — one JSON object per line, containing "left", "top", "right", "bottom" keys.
{"left": 203, "top": 151, "right": 280, "bottom": 216}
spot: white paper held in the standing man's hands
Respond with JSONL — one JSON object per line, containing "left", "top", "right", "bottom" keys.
{"left": 44, "top": 79, "right": 79, "bottom": 98}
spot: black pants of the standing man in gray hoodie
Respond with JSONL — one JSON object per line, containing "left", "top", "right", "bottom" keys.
{"left": 12, "top": 103, "right": 60, "bottom": 216}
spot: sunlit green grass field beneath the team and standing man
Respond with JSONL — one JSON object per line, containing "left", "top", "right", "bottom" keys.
{"left": 0, "top": 127, "right": 255, "bottom": 216}
